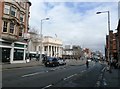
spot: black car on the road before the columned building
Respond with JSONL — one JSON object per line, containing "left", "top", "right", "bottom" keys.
{"left": 44, "top": 57, "right": 59, "bottom": 67}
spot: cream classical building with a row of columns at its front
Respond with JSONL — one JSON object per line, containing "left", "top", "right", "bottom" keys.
{"left": 42, "top": 36, "right": 63, "bottom": 57}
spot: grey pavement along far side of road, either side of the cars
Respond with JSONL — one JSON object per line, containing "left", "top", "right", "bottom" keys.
{"left": 0, "top": 59, "right": 85, "bottom": 70}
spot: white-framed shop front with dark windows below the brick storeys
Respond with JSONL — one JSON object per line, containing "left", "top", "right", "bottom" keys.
{"left": 0, "top": 40, "right": 27, "bottom": 63}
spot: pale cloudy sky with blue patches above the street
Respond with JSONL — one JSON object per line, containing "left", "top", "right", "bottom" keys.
{"left": 30, "top": 0, "right": 118, "bottom": 53}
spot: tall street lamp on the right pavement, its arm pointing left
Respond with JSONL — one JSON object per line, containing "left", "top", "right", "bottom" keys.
{"left": 96, "top": 11, "right": 111, "bottom": 70}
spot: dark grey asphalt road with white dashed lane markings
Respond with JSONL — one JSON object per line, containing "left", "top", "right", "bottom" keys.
{"left": 2, "top": 62, "right": 104, "bottom": 89}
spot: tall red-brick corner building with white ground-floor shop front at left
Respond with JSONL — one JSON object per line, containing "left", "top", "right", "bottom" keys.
{"left": 0, "top": 0, "right": 31, "bottom": 63}
